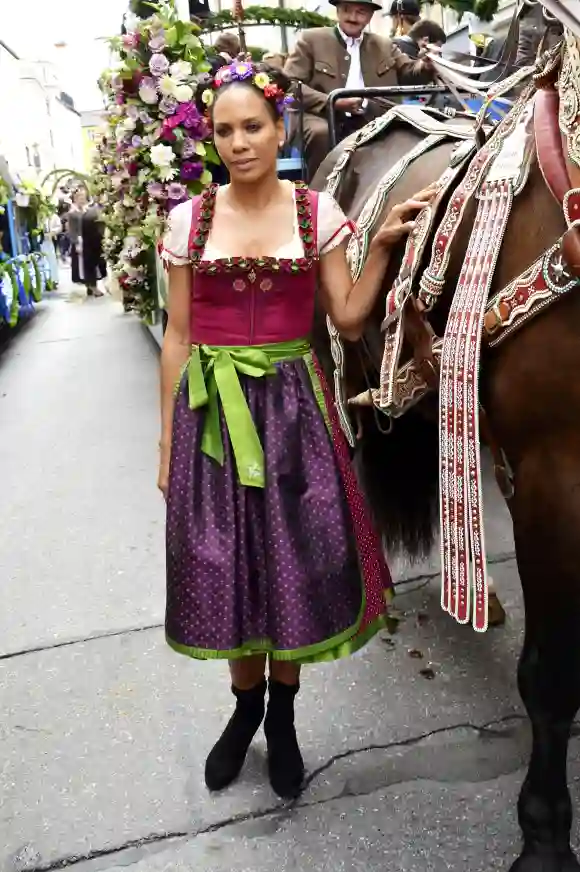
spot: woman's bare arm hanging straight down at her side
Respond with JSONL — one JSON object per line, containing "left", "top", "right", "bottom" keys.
{"left": 159, "top": 264, "right": 192, "bottom": 495}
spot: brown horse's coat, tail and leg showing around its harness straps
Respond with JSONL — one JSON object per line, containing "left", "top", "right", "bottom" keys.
{"left": 313, "top": 27, "right": 580, "bottom": 872}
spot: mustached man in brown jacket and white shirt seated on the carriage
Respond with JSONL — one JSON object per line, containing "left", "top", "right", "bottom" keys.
{"left": 284, "top": 0, "right": 432, "bottom": 180}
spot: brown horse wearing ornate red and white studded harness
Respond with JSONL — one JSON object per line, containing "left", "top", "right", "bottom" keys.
{"left": 312, "top": 18, "right": 580, "bottom": 872}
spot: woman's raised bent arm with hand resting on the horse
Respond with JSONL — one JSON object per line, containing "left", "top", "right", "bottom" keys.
{"left": 320, "top": 186, "right": 436, "bottom": 341}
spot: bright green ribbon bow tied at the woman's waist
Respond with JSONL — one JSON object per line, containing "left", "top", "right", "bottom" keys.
{"left": 187, "top": 339, "right": 310, "bottom": 487}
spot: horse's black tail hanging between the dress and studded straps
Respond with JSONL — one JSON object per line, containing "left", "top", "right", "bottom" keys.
{"left": 356, "top": 409, "right": 439, "bottom": 560}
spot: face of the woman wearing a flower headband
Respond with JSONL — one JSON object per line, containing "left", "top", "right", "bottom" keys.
{"left": 213, "top": 85, "right": 284, "bottom": 183}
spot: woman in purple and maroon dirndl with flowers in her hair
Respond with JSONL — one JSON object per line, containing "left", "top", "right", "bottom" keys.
{"left": 159, "top": 62, "right": 432, "bottom": 798}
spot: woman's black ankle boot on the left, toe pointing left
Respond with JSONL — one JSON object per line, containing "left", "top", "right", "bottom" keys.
{"left": 205, "top": 681, "right": 266, "bottom": 790}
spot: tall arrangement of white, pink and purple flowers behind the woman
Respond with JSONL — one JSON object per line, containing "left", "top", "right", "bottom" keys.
{"left": 93, "top": 0, "right": 219, "bottom": 317}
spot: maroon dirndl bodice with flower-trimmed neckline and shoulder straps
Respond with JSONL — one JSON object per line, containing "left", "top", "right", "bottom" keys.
{"left": 189, "top": 185, "right": 318, "bottom": 346}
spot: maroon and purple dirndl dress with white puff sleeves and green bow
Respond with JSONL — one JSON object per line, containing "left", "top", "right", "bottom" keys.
{"left": 163, "top": 186, "right": 391, "bottom": 663}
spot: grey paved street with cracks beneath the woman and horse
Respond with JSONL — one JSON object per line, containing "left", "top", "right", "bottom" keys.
{"left": 0, "top": 280, "right": 580, "bottom": 872}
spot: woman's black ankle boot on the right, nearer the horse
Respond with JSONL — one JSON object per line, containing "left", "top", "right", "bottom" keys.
{"left": 264, "top": 679, "right": 304, "bottom": 799}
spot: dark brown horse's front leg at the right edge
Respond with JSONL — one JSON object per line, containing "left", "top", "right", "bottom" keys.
{"left": 511, "top": 450, "right": 580, "bottom": 872}
